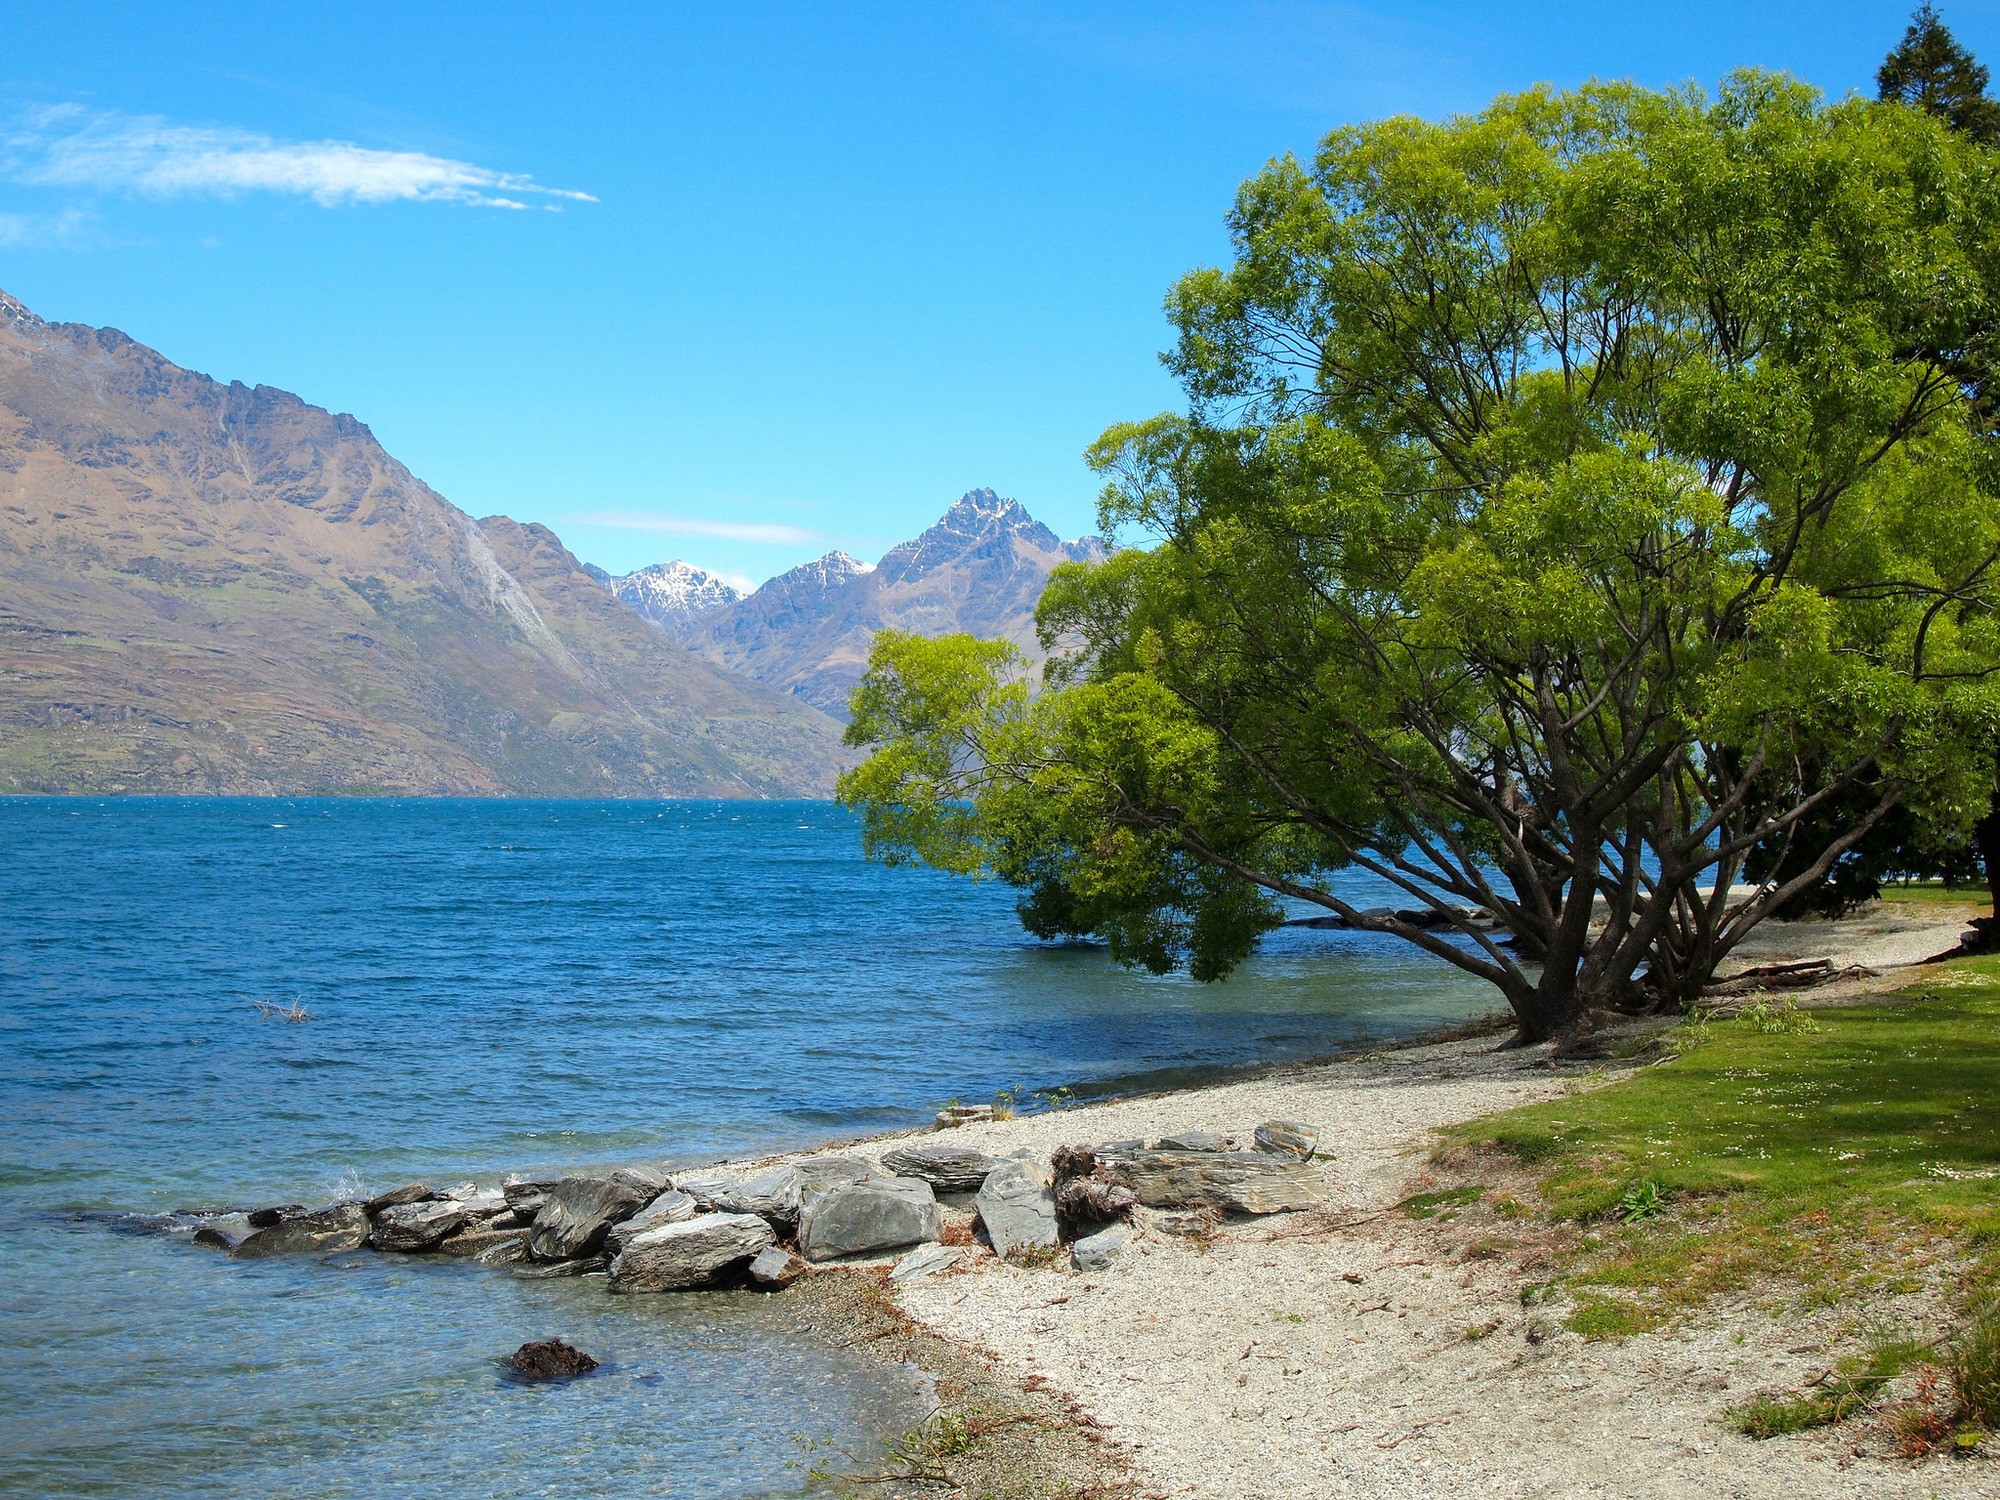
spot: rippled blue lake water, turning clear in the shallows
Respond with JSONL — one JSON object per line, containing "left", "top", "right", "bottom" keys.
{"left": 0, "top": 798, "right": 1496, "bottom": 1496}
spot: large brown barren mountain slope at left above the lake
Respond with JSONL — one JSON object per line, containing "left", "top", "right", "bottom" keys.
{"left": 0, "top": 294, "right": 840, "bottom": 796}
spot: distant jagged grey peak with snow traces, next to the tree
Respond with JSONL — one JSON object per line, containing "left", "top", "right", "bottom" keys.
{"left": 682, "top": 490, "right": 1104, "bottom": 718}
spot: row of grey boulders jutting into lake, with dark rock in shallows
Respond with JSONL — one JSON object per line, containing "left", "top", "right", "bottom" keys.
{"left": 162, "top": 1120, "right": 1326, "bottom": 1312}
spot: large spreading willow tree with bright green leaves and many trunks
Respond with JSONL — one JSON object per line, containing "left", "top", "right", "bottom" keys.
{"left": 840, "top": 74, "right": 2000, "bottom": 1040}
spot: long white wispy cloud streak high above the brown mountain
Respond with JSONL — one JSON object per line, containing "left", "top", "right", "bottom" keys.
{"left": 6, "top": 104, "right": 596, "bottom": 208}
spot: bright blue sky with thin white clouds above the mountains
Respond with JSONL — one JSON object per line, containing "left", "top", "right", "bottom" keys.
{"left": 0, "top": 0, "right": 2000, "bottom": 584}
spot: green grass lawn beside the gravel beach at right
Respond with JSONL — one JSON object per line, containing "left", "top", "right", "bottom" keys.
{"left": 1454, "top": 976, "right": 2000, "bottom": 1334}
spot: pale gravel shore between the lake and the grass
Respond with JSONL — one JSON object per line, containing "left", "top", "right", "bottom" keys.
{"left": 796, "top": 914, "right": 2000, "bottom": 1500}
